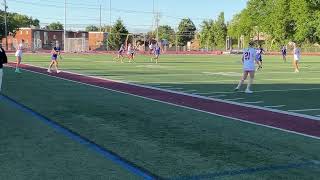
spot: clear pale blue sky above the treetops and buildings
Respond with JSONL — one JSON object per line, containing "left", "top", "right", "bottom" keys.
{"left": 7, "top": 0, "right": 247, "bottom": 32}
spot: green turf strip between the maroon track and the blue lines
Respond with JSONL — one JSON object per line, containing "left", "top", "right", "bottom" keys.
{"left": 4, "top": 67, "right": 320, "bottom": 179}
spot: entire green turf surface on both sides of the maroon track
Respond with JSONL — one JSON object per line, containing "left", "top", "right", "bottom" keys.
{"left": 0, "top": 55, "right": 320, "bottom": 179}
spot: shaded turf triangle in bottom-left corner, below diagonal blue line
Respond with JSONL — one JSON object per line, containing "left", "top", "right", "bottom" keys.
{"left": 0, "top": 98, "right": 138, "bottom": 180}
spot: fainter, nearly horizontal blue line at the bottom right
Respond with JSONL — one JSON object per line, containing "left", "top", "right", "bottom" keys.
{"left": 170, "top": 161, "right": 320, "bottom": 180}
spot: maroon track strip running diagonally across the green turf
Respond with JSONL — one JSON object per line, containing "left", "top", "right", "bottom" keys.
{"left": 9, "top": 64, "right": 320, "bottom": 138}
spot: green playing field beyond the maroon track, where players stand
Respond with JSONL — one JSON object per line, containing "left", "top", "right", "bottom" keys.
{"left": 10, "top": 52, "right": 320, "bottom": 116}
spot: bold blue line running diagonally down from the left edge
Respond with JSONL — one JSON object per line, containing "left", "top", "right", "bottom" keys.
{"left": 0, "top": 95, "right": 159, "bottom": 180}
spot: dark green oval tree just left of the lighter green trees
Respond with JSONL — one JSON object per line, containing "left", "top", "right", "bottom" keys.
{"left": 177, "top": 18, "right": 197, "bottom": 46}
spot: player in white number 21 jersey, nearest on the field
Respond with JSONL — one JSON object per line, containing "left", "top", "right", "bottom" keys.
{"left": 235, "top": 42, "right": 261, "bottom": 93}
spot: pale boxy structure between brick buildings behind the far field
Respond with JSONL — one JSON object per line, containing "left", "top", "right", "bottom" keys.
{"left": 65, "top": 38, "right": 89, "bottom": 52}
